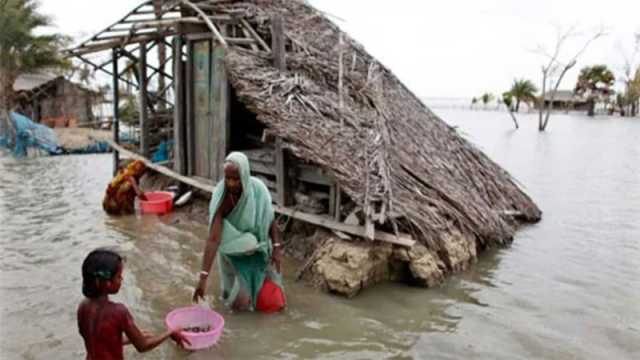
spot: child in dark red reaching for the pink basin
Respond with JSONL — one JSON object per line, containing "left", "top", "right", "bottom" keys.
{"left": 78, "top": 249, "right": 188, "bottom": 360}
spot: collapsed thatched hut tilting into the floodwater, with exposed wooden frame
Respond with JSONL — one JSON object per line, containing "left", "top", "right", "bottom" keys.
{"left": 69, "top": 0, "right": 541, "bottom": 294}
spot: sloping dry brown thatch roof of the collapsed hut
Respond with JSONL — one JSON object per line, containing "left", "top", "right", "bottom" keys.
{"left": 72, "top": 0, "right": 541, "bottom": 250}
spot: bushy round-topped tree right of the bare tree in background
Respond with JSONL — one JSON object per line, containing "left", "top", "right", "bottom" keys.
{"left": 575, "top": 65, "right": 616, "bottom": 116}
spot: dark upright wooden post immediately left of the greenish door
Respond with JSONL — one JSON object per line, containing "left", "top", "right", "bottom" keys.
{"left": 173, "top": 36, "right": 187, "bottom": 175}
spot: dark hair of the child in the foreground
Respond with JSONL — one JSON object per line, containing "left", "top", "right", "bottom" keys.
{"left": 82, "top": 249, "right": 123, "bottom": 299}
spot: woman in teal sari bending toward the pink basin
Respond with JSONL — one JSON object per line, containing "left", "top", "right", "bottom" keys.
{"left": 193, "top": 152, "right": 284, "bottom": 310}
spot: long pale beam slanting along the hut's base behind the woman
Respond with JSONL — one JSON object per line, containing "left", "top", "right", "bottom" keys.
{"left": 99, "top": 136, "right": 415, "bottom": 247}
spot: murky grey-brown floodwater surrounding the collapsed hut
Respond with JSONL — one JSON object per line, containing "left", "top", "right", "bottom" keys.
{"left": 0, "top": 110, "right": 640, "bottom": 359}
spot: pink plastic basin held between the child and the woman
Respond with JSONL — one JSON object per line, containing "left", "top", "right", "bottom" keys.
{"left": 165, "top": 305, "right": 224, "bottom": 350}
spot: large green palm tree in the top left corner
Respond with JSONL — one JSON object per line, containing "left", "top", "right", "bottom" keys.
{"left": 0, "top": 0, "right": 69, "bottom": 110}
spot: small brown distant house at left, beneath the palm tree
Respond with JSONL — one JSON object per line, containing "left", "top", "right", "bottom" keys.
{"left": 13, "top": 74, "right": 98, "bottom": 127}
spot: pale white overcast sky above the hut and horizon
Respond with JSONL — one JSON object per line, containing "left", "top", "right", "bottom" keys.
{"left": 41, "top": 0, "right": 640, "bottom": 98}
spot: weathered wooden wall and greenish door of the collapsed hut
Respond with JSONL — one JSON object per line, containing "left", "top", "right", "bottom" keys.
{"left": 171, "top": 34, "right": 346, "bottom": 219}
